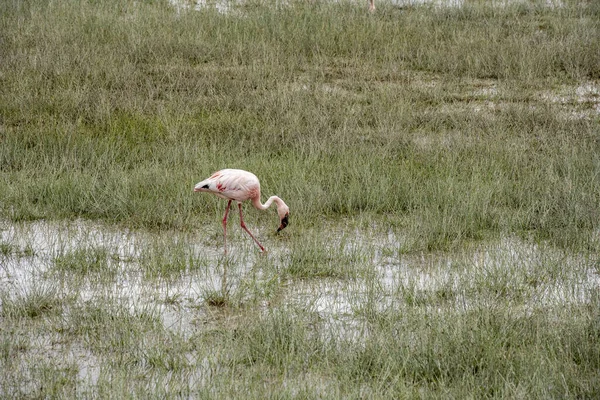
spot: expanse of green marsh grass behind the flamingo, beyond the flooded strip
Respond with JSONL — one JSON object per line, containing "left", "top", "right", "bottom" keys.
{"left": 0, "top": 1, "right": 600, "bottom": 249}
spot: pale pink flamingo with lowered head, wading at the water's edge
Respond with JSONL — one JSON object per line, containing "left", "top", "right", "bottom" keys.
{"left": 194, "top": 168, "right": 290, "bottom": 254}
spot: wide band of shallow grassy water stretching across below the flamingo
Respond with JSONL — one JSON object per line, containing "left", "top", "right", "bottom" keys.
{"left": 0, "top": 220, "right": 600, "bottom": 381}
